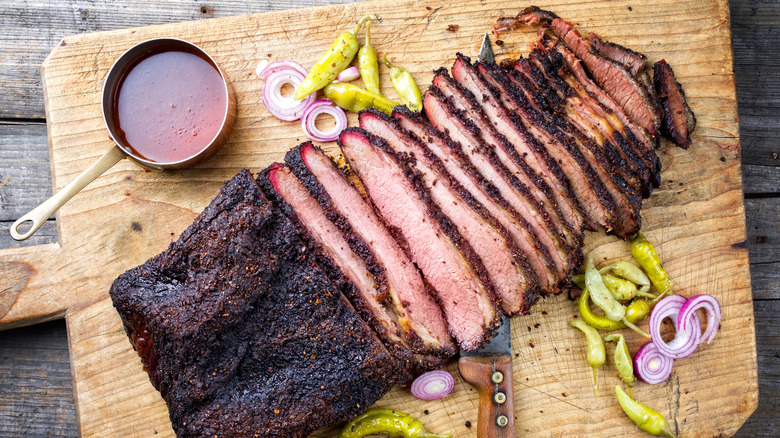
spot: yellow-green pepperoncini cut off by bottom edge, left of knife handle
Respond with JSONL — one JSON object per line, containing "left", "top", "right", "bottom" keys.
{"left": 338, "top": 409, "right": 452, "bottom": 438}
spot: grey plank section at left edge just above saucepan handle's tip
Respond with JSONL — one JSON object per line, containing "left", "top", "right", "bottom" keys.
{"left": 0, "top": 122, "right": 52, "bottom": 221}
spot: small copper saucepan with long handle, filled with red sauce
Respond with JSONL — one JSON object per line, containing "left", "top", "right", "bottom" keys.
{"left": 11, "top": 38, "right": 236, "bottom": 240}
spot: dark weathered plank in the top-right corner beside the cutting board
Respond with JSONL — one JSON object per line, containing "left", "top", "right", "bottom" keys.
{"left": 730, "top": 0, "right": 780, "bottom": 166}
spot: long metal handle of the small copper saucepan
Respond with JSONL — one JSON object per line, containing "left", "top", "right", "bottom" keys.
{"left": 11, "top": 145, "right": 126, "bottom": 240}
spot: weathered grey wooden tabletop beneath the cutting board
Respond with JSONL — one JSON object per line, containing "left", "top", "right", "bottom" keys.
{"left": 0, "top": 0, "right": 780, "bottom": 437}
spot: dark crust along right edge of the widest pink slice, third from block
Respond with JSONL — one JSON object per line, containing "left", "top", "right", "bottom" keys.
{"left": 339, "top": 127, "right": 501, "bottom": 350}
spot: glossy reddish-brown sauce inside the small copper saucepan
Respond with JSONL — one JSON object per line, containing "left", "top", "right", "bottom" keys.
{"left": 114, "top": 51, "right": 227, "bottom": 163}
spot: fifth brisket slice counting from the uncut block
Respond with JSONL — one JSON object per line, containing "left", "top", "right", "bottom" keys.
{"left": 393, "top": 107, "right": 558, "bottom": 296}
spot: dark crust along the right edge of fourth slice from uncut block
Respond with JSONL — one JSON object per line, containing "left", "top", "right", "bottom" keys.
{"left": 359, "top": 109, "right": 538, "bottom": 315}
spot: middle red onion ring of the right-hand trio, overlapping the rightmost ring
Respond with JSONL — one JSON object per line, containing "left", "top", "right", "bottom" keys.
{"left": 649, "top": 295, "right": 701, "bottom": 359}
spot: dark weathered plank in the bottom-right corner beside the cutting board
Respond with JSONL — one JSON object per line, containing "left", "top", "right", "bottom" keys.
{"left": 735, "top": 300, "right": 780, "bottom": 438}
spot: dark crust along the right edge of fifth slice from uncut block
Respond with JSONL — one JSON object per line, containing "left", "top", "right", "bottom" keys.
{"left": 393, "top": 107, "right": 556, "bottom": 298}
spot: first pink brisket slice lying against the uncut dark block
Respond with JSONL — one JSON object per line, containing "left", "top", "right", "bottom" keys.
{"left": 257, "top": 163, "right": 441, "bottom": 373}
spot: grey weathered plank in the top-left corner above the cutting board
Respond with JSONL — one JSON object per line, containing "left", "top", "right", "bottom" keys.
{"left": 0, "top": 0, "right": 352, "bottom": 119}
